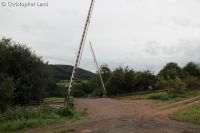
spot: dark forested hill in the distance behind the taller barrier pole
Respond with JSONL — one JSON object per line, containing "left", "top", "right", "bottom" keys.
{"left": 49, "top": 65, "right": 94, "bottom": 81}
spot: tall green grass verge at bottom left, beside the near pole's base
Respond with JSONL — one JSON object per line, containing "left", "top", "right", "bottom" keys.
{"left": 0, "top": 105, "right": 83, "bottom": 133}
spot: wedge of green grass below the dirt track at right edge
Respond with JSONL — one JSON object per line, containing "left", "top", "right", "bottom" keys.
{"left": 171, "top": 104, "right": 200, "bottom": 124}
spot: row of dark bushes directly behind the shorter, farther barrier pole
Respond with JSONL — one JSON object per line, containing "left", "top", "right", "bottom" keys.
{"left": 79, "top": 65, "right": 158, "bottom": 96}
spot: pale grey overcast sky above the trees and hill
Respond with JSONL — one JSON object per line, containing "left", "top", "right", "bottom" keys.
{"left": 0, "top": 0, "right": 200, "bottom": 72}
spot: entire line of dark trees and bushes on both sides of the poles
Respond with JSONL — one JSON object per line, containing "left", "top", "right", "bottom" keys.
{"left": 0, "top": 38, "right": 200, "bottom": 112}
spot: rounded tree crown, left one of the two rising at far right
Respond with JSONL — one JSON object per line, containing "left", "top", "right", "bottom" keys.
{"left": 158, "top": 62, "right": 184, "bottom": 80}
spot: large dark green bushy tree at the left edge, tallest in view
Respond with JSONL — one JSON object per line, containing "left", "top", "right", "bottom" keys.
{"left": 0, "top": 38, "right": 51, "bottom": 105}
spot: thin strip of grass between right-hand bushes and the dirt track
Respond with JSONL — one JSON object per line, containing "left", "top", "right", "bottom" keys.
{"left": 123, "top": 91, "right": 200, "bottom": 102}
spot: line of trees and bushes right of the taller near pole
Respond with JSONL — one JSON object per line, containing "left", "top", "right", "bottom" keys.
{"left": 74, "top": 62, "right": 200, "bottom": 96}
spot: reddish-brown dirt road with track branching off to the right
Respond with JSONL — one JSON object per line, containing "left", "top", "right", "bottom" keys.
{"left": 25, "top": 98, "right": 200, "bottom": 133}
